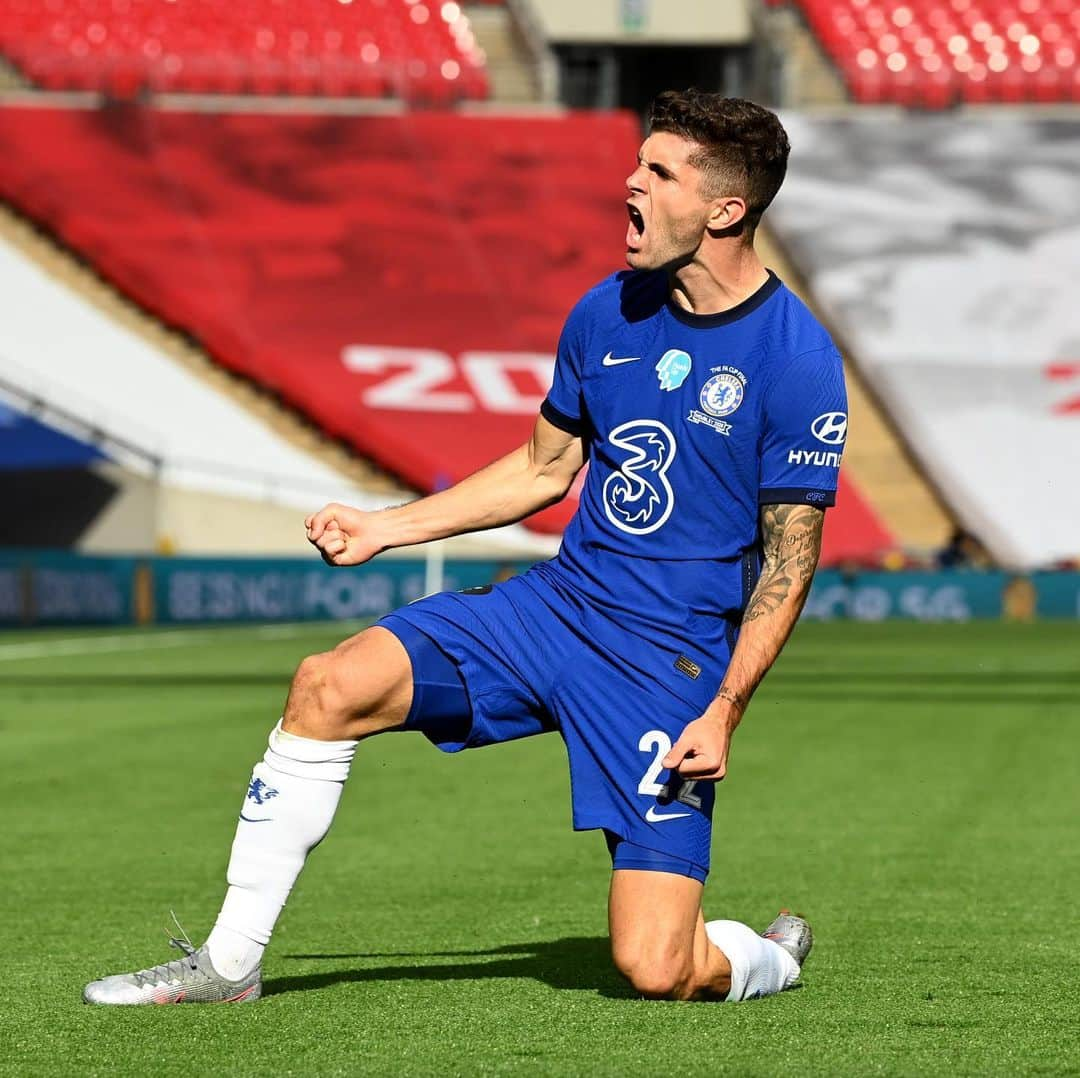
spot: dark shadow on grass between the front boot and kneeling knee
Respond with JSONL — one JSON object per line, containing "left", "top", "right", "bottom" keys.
{"left": 262, "top": 936, "right": 635, "bottom": 999}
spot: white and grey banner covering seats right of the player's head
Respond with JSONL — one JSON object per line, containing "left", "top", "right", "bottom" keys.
{"left": 769, "top": 110, "right": 1080, "bottom": 568}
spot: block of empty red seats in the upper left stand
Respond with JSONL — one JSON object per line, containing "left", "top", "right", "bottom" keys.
{"left": 0, "top": 0, "right": 488, "bottom": 104}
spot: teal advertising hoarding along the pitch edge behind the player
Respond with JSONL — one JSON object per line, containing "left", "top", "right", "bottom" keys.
{"left": 0, "top": 553, "right": 1080, "bottom": 626}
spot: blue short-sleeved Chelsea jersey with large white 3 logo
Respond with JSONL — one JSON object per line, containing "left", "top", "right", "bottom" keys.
{"left": 541, "top": 271, "right": 847, "bottom": 647}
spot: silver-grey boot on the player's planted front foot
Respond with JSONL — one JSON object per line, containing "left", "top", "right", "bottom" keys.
{"left": 82, "top": 939, "right": 262, "bottom": 1006}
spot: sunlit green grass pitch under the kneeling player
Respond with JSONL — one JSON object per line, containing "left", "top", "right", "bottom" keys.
{"left": 0, "top": 623, "right": 1080, "bottom": 1078}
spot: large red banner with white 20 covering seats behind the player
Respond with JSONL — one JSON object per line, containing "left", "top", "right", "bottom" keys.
{"left": 0, "top": 107, "right": 893, "bottom": 563}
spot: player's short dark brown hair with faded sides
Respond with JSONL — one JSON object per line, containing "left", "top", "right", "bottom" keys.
{"left": 649, "top": 90, "right": 791, "bottom": 228}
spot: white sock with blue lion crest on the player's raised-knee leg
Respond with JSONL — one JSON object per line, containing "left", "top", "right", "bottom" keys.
{"left": 206, "top": 723, "right": 359, "bottom": 981}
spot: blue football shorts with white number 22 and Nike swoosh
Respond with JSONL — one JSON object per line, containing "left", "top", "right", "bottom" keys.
{"left": 378, "top": 564, "right": 729, "bottom": 881}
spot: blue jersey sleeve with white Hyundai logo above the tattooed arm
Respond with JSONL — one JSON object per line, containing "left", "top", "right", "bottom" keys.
{"left": 757, "top": 345, "right": 848, "bottom": 509}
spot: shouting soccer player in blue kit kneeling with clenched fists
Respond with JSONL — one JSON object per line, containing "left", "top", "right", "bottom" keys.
{"left": 84, "top": 91, "right": 847, "bottom": 1003}
